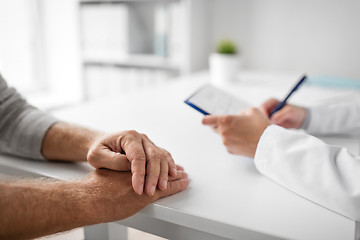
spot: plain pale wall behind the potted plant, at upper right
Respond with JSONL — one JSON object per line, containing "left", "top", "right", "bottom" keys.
{"left": 211, "top": 0, "right": 360, "bottom": 77}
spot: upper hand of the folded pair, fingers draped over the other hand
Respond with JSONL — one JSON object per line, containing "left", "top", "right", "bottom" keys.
{"left": 87, "top": 131, "right": 177, "bottom": 196}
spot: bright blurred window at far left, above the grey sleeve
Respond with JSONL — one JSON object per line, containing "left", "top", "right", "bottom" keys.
{"left": 0, "top": 0, "right": 45, "bottom": 94}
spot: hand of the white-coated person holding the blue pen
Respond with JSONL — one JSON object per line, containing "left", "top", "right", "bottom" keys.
{"left": 260, "top": 98, "right": 306, "bottom": 128}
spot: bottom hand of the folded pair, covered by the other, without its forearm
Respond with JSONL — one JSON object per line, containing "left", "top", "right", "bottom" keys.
{"left": 83, "top": 166, "right": 189, "bottom": 223}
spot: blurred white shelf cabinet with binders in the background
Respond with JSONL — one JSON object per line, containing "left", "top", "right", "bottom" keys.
{"left": 79, "top": 0, "right": 210, "bottom": 99}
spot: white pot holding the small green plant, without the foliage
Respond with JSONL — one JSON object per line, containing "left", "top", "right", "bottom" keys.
{"left": 209, "top": 53, "right": 240, "bottom": 86}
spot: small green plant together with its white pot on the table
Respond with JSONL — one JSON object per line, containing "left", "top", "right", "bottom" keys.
{"left": 209, "top": 39, "right": 240, "bottom": 85}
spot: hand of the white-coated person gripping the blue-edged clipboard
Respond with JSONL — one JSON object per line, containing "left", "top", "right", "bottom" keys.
{"left": 202, "top": 108, "right": 271, "bottom": 158}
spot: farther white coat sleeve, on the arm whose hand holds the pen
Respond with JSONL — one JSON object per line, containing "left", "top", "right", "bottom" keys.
{"left": 305, "top": 103, "right": 360, "bottom": 136}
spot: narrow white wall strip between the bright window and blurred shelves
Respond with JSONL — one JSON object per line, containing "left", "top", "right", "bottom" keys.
{"left": 42, "top": 0, "right": 82, "bottom": 102}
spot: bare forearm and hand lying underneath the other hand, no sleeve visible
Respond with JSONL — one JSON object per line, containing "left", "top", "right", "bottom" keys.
{"left": 0, "top": 166, "right": 189, "bottom": 239}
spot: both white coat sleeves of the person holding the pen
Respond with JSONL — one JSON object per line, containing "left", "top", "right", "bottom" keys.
{"left": 254, "top": 103, "right": 360, "bottom": 221}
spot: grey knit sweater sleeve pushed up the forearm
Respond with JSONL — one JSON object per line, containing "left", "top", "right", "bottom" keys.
{"left": 0, "top": 75, "right": 57, "bottom": 159}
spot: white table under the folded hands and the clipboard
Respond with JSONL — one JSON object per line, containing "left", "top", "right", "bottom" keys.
{"left": 0, "top": 72, "right": 360, "bottom": 240}
